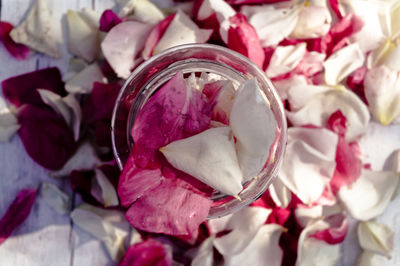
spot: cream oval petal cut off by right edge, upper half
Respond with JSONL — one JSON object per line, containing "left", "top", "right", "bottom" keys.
{"left": 364, "top": 66, "right": 400, "bottom": 126}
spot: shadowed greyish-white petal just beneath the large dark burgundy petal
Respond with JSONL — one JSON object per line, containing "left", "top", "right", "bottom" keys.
{"left": 50, "top": 142, "right": 101, "bottom": 177}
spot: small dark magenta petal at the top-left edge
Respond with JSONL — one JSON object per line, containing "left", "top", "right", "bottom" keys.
{"left": 0, "top": 21, "right": 31, "bottom": 60}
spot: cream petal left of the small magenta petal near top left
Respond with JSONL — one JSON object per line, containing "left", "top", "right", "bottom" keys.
{"left": 67, "top": 10, "right": 100, "bottom": 62}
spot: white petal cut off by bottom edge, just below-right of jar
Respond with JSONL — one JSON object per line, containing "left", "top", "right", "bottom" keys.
{"left": 224, "top": 224, "right": 283, "bottom": 266}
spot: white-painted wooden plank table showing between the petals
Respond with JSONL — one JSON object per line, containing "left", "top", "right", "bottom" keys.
{"left": 0, "top": 0, "right": 400, "bottom": 266}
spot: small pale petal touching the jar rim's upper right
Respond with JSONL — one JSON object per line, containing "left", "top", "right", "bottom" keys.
{"left": 266, "top": 43, "right": 307, "bottom": 78}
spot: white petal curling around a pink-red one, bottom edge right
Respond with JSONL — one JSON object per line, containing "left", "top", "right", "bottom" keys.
{"left": 296, "top": 220, "right": 341, "bottom": 266}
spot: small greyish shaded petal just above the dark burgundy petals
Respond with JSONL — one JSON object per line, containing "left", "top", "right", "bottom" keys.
{"left": 65, "top": 63, "right": 107, "bottom": 94}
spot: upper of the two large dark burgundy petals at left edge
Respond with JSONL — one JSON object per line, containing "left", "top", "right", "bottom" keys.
{"left": 1, "top": 67, "right": 65, "bottom": 107}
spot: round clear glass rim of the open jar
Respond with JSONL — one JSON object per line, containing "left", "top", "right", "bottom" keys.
{"left": 111, "top": 44, "right": 287, "bottom": 219}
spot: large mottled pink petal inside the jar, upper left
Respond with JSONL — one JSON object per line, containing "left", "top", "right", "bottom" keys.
{"left": 131, "top": 72, "right": 211, "bottom": 168}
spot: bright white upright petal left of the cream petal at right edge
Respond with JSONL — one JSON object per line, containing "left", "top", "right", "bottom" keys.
{"left": 323, "top": 43, "right": 365, "bottom": 85}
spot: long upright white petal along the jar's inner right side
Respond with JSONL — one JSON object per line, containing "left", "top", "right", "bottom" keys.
{"left": 230, "top": 79, "right": 277, "bottom": 181}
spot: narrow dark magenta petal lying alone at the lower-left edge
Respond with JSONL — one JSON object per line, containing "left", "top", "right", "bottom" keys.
{"left": 0, "top": 188, "right": 37, "bottom": 245}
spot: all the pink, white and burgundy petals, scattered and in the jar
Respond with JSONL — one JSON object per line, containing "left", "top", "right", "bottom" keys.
{"left": 0, "top": 0, "right": 400, "bottom": 266}
